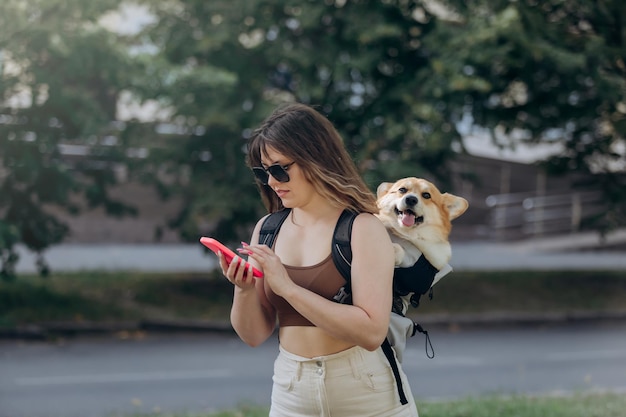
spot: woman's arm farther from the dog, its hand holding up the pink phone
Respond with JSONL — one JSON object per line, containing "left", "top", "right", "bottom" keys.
{"left": 220, "top": 218, "right": 276, "bottom": 347}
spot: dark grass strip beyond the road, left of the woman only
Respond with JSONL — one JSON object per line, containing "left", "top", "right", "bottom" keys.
{"left": 0, "top": 272, "right": 232, "bottom": 328}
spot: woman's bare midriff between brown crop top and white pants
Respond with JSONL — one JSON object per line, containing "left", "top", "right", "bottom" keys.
{"left": 279, "top": 326, "right": 354, "bottom": 358}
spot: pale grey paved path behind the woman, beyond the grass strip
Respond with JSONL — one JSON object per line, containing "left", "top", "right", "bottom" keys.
{"left": 13, "top": 230, "right": 626, "bottom": 273}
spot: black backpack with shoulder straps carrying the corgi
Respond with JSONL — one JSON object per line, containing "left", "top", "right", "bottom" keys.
{"left": 259, "top": 209, "right": 436, "bottom": 404}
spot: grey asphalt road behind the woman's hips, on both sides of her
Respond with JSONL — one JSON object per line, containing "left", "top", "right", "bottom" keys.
{"left": 0, "top": 324, "right": 626, "bottom": 417}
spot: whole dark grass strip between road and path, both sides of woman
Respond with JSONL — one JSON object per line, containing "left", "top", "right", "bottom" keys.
{"left": 0, "top": 271, "right": 626, "bottom": 328}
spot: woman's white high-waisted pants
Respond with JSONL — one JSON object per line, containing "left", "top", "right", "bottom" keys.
{"left": 269, "top": 346, "right": 418, "bottom": 417}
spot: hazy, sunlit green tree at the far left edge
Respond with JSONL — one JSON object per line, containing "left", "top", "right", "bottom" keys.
{"left": 0, "top": 0, "right": 135, "bottom": 277}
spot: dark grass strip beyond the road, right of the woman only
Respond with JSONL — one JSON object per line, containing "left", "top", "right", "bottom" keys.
{"left": 400, "top": 271, "right": 626, "bottom": 315}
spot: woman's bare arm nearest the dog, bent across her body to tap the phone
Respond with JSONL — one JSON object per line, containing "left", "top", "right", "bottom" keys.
{"left": 243, "top": 214, "right": 394, "bottom": 350}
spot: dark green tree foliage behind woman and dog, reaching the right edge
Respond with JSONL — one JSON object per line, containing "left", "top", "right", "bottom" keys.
{"left": 139, "top": 0, "right": 626, "bottom": 238}
